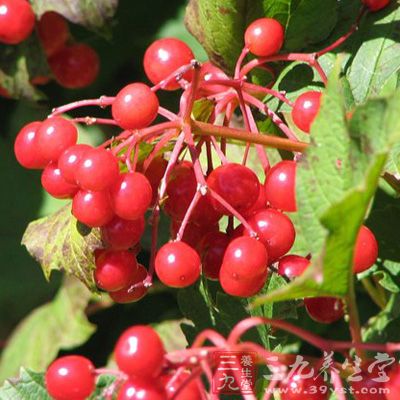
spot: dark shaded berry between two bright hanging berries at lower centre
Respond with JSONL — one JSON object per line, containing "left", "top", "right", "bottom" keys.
{"left": 200, "top": 231, "right": 230, "bottom": 279}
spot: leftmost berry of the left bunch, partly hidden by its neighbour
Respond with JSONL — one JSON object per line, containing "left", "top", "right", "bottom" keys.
{"left": 14, "top": 121, "right": 47, "bottom": 169}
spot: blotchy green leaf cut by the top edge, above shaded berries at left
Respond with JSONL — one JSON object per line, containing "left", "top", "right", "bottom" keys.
{"left": 31, "top": 0, "right": 118, "bottom": 33}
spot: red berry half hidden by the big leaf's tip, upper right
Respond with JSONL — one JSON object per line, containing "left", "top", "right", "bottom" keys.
{"left": 292, "top": 91, "right": 322, "bottom": 133}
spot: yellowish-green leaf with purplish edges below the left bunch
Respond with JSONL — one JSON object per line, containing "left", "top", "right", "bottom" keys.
{"left": 22, "top": 204, "right": 102, "bottom": 291}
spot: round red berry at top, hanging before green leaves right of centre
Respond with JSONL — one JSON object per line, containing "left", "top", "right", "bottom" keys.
{"left": 244, "top": 18, "right": 285, "bottom": 57}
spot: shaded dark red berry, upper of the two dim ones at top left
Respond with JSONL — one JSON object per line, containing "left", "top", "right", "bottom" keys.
{"left": 37, "top": 11, "right": 69, "bottom": 57}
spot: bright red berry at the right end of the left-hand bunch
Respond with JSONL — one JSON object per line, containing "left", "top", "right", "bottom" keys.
{"left": 111, "top": 172, "right": 153, "bottom": 220}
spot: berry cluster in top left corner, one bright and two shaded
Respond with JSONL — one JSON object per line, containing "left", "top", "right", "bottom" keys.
{"left": 0, "top": 0, "right": 99, "bottom": 97}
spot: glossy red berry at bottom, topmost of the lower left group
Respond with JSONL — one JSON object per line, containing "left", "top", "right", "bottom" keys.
{"left": 114, "top": 325, "right": 165, "bottom": 378}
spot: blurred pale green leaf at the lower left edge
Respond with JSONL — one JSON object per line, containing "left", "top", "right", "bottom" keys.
{"left": 0, "top": 278, "right": 95, "bottom": 381}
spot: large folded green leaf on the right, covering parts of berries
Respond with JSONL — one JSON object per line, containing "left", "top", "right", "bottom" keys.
{"left": 253, "top": 65, "right": 400, "bottom": 305}
